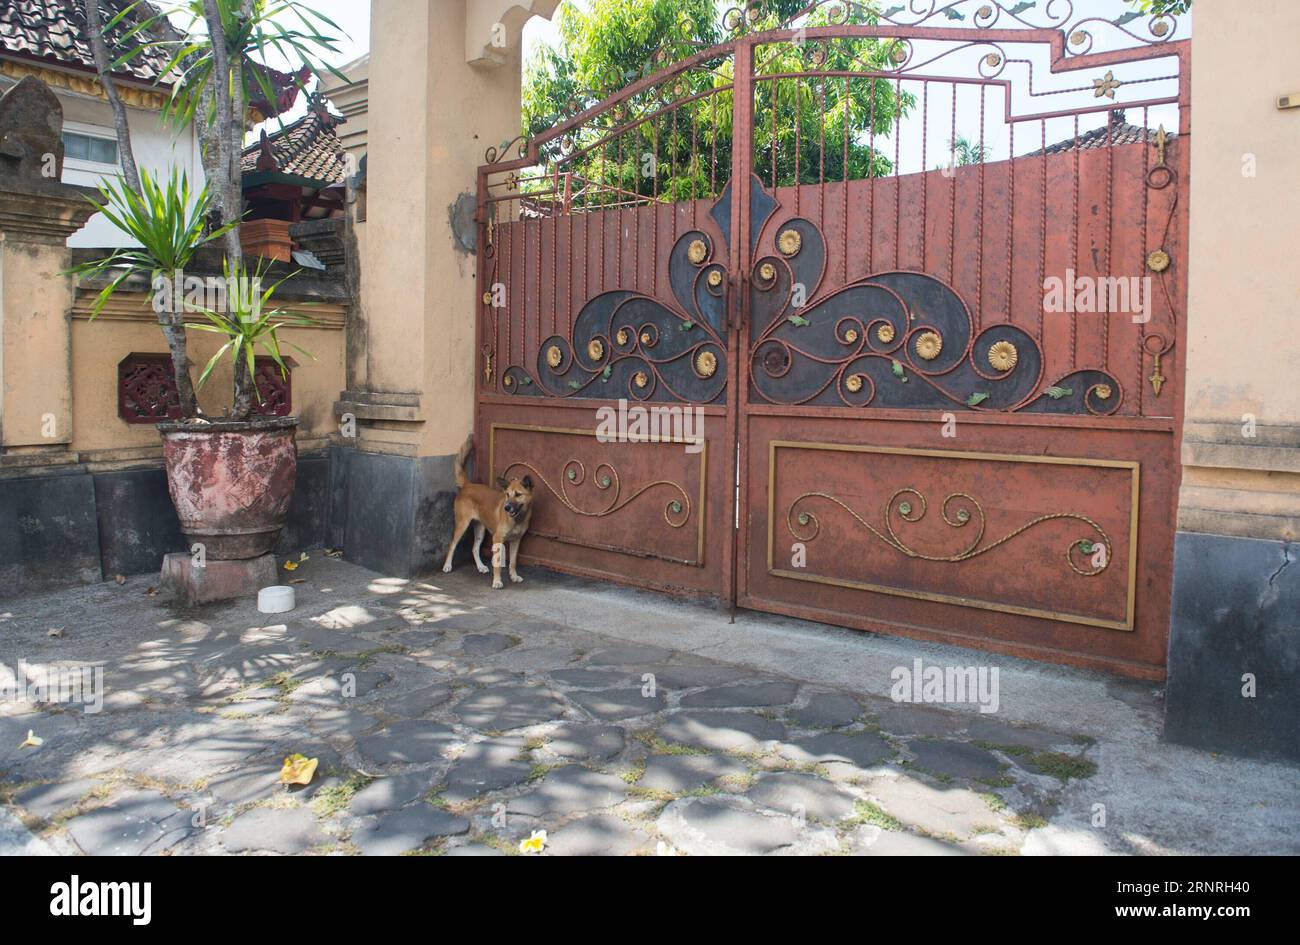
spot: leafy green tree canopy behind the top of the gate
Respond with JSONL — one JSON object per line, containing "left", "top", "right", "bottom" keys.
{"left": 523, "top": 0, "right": 913, "bottom": 204}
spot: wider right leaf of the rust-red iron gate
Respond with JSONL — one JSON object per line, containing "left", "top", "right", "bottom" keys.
{"left": 738, "top": 3, "right": 1190, "bottom": 677}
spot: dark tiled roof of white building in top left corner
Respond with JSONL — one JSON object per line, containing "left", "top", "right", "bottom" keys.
{"left": 0, "top": 0, "right": 169, "bottom": 82}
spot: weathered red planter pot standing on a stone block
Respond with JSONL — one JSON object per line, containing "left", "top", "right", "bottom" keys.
{"left": 157, "top": 417, "right": 298, "bottom": 560}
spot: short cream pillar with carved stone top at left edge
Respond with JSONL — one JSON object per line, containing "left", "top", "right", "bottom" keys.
{"left": 0, "top": 78, "right": 100, "bottom": 595}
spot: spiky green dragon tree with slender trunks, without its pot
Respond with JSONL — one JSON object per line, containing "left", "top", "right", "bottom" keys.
{"left": 78, "top": 0, "right": 346, "bottom": 421}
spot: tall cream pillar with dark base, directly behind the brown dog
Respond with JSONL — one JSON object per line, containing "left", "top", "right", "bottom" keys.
{"left": 332, "top": 0, "right": 554, "bottom": 575}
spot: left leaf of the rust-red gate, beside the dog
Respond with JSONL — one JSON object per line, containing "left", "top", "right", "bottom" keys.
{"left": 476, "top": 47, "right": 736, "bottom": 598}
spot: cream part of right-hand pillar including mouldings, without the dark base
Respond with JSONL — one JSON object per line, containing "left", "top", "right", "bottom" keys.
{"left": 1179, "top": 0, "right": 1300, "bottom": 541}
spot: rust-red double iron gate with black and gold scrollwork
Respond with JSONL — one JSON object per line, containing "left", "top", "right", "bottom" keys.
{"left": 477, "top": 0, "right": 1190, "bottom": 677}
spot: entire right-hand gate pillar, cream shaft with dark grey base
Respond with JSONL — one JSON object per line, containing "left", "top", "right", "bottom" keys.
{"left": 1165, "top": 0, "right": 1300, "bottom": 758}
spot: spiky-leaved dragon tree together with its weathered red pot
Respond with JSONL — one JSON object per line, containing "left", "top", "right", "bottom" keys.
{"left": 75, "top": 0, "right": 339, "bottom": 579}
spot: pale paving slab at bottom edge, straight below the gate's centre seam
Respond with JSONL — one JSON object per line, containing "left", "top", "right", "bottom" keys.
{"left": 655, "top": 797, "right": 816, "bottom": 857}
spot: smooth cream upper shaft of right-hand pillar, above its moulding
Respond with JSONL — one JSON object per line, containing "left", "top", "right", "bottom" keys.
{"left": 1187, "top": 0, "right": 1300, "bottom": 424}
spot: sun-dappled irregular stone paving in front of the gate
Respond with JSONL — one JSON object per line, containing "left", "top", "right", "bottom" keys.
{"left": 0, "top": 559, "right": 1112, "bottom": 857}
